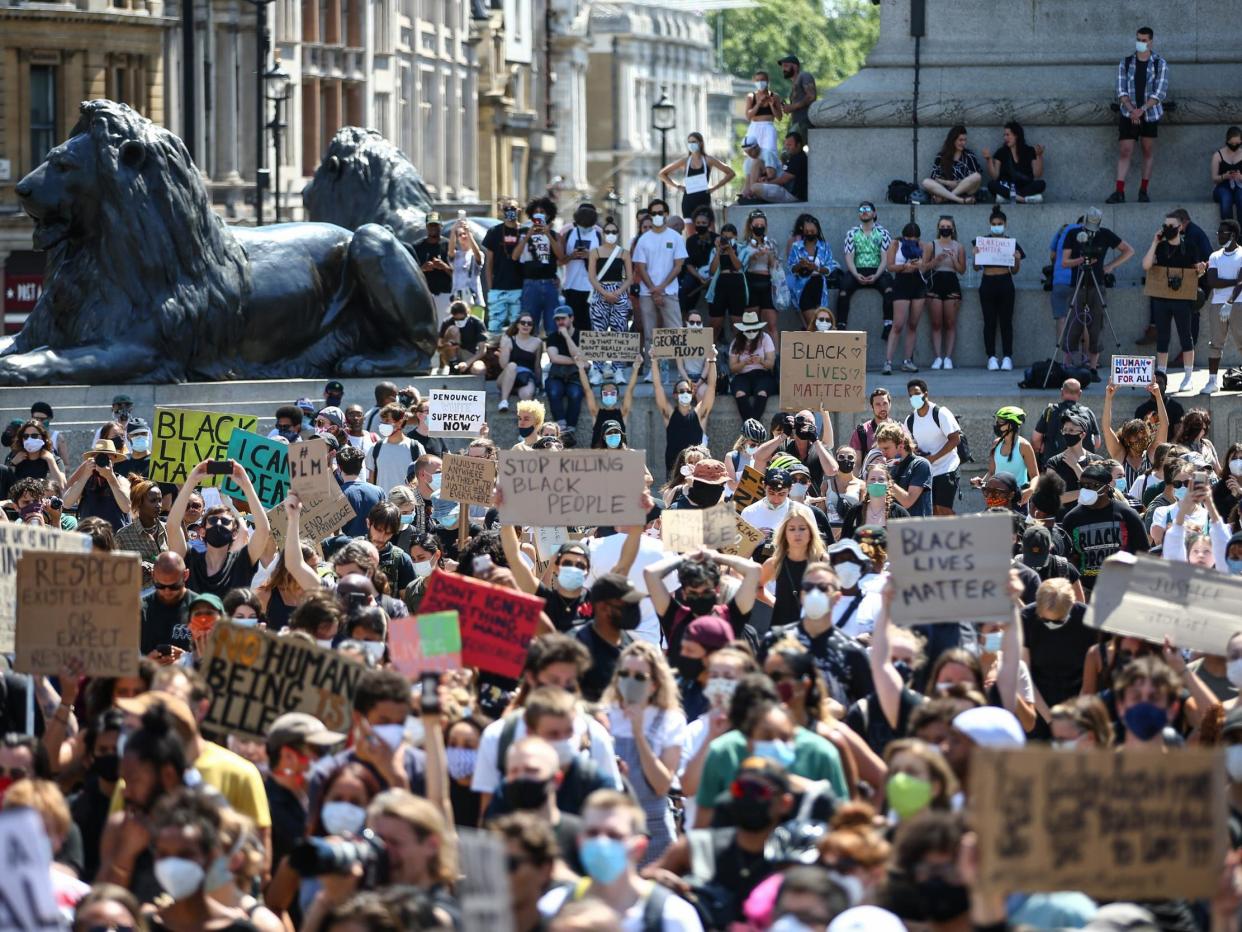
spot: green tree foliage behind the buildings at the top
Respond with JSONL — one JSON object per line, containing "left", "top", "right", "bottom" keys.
{"left": 710, "top": 0, "right": 879, "bottom": 98}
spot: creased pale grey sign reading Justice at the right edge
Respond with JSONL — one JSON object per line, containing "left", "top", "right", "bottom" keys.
{"left": 1084, "top": 554, "right": 1242, "bottom": 655}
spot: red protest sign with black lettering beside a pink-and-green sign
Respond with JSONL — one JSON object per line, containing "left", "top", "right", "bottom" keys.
{"left": 419, "top": 569, "right": 543, "bottom": 678}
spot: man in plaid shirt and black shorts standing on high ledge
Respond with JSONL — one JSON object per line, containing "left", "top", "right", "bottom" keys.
{"left": 1107, "top": 26, "right": 1169, "bottom": 204}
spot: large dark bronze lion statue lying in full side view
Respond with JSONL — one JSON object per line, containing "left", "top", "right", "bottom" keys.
{"left": 0, "top": 101, "right": 437, "bottom": 385}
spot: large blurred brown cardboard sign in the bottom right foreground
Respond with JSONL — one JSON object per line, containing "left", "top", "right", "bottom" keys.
{"left": 970, "top": 746, "right": 1228, "bottom": 900}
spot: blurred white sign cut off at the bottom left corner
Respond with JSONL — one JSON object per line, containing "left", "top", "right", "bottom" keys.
{"left": 0, "top": 806, "right": 65, "bottom": 932}
